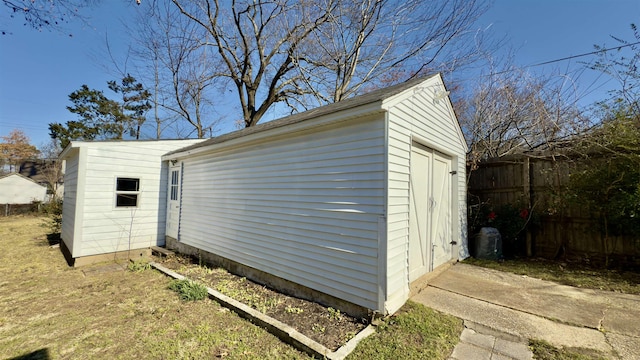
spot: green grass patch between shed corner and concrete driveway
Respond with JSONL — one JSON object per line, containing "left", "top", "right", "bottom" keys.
{"left": 347, "top": 301, "right": 463, "bottom": 360}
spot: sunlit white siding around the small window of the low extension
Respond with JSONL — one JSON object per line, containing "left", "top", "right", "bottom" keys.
{"left": 63, "top": 140, "right": 199, "bottom": 257}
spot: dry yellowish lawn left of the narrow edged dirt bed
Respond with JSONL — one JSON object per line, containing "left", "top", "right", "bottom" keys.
{"left": 0, "top": 217, "right": 307, "bottom": 359}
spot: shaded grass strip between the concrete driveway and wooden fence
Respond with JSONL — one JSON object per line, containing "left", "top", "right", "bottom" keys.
{"left": 464, "top": 258, "right": 640, "bottom": 295}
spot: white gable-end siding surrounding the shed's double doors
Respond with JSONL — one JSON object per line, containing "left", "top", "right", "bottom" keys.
{"left": 386, "top": 77, "right": 466, "bottom": 313}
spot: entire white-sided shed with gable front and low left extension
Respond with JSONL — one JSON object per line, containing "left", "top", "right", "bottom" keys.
{"left": 62, "top": 75, "right": 467, "bottom": 314}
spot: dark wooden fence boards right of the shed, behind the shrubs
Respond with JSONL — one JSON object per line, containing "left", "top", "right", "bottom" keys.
{"left": 469, "top": 156, "right": 640, "bottom": 263}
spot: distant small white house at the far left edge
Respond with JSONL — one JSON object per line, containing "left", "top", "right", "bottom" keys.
{"left": 0, "top": 173, "right": 47, "bottom": 205}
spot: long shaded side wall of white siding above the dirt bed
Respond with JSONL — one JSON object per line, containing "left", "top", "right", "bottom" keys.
{"left": 180, "top": 115, "right": 385, "bottom": 309}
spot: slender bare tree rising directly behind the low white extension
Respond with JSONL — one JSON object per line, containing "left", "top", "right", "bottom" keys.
{"left": 129, "top": 2, "right": 217, "bottom": 138}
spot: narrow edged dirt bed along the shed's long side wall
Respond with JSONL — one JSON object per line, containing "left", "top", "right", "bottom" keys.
{"left": 156, "top": 255, "right": 368, "bottom": 351}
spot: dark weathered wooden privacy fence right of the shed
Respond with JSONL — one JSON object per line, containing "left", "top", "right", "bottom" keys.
{"left": 468, "top": 156, "right": 640, "bottom": 265}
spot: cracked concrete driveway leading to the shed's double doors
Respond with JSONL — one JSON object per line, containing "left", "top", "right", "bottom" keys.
{"left": 412, "top": 263, "right": 640, "bottom": 359}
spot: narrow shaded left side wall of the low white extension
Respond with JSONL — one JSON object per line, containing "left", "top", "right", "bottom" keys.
{"left": 61, "top": 150, "right": 79, "bottom": 252}
